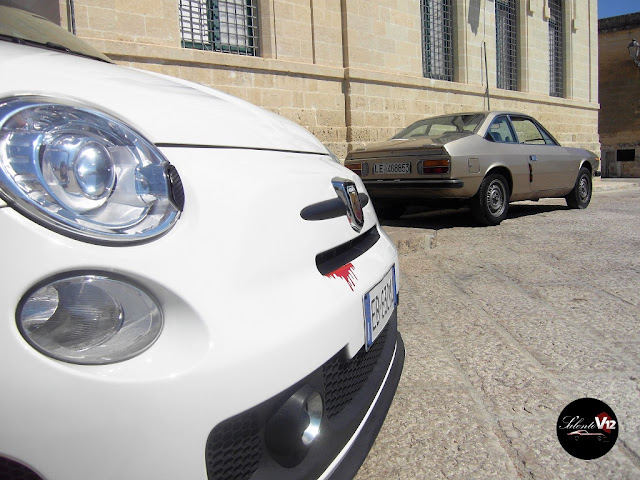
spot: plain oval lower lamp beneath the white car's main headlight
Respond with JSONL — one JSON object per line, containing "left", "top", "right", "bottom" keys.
{"left": 16, "top": 274, "right": 162, "bottom": 365}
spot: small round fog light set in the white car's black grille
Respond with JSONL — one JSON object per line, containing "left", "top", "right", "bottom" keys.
{"left": 266, "top": 386, "right": 324, "bottom": 468}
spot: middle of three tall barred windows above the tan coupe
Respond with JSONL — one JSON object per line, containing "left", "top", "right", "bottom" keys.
{"left": 496, "top": 0, "right": 518, "bottom": 90}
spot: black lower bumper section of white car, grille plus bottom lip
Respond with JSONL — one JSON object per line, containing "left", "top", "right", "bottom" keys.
{"left": 206, "top": 315, "right": 404, "bottom": 480}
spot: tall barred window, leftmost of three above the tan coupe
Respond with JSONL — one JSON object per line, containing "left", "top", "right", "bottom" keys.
{"left": 420, "top": 0, "right": 453, "bottom": 81}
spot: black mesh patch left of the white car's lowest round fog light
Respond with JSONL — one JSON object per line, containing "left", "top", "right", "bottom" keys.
{"left": 206, "top": 415, "right": 262, "bottom": 480}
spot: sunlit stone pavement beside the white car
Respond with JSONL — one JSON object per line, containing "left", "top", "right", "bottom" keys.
{"left": 356, "top": 188, "right": 640, "bottom": 480}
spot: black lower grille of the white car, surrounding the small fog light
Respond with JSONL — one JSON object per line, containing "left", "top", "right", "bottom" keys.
{"left": 205, "top": 317, "right": 397, "bottom": 480}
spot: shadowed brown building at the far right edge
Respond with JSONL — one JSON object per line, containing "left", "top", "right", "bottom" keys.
{"left": 598, "top": 13, "right": 640, "bottom": 177}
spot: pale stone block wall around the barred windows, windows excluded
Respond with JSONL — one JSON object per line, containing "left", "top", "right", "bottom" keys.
{"left": 60, "top": 0, "right": 600, "bottom": 158}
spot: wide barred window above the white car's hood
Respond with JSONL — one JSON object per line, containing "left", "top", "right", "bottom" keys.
{"left": 180, "top": 0, "right": 258, "bottom": 56}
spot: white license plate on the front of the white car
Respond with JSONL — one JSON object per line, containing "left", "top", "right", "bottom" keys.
{"left": 363, "top": 266, "right": 398, "bottom": 350}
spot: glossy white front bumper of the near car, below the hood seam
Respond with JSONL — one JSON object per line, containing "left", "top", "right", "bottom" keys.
{"left": 0, "top": 148, "right": 403, "bottom": 480}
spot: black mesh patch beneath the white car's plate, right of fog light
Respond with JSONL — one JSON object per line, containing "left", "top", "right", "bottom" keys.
{"left": 322, "top": 325, "right": 389, "bottom": 418}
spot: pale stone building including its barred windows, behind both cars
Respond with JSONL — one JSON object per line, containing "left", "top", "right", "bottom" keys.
{"left": 4, "top": 0, "right": 600, "bottom": 158}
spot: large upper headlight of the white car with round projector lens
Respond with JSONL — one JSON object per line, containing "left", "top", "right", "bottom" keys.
{"left": 0, "top": 97, "right": 184, "bottom": 243}
